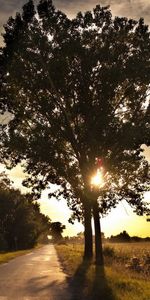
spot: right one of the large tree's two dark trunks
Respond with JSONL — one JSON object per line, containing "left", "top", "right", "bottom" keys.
{"left": 93, "top": 199, "right": 104, "bottom": 266}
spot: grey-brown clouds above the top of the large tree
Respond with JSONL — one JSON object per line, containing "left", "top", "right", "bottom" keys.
{"left": 0, "top": 0, "right": 150, "bottom": 45}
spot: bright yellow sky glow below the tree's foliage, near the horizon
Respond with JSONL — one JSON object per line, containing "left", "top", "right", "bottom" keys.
{"left": 0, "top": 146, "right": 150, "bottom": 237}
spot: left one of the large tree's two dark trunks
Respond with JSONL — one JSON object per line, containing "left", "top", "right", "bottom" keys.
{"left": 83, "top": 199, "right": 93, "bottom": 260}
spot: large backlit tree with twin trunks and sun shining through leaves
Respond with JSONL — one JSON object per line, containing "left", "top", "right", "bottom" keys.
{"left": 1, "top": 0, "right": 150, "bottom": 264}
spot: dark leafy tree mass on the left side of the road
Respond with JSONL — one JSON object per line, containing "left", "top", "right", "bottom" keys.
{"left": 0, "top": 173, "right": 50, "bottom": 250}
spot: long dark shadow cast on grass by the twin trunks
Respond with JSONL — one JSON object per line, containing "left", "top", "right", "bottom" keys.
{"left": 70, "top": 261, "right": 116, "bottom": 300}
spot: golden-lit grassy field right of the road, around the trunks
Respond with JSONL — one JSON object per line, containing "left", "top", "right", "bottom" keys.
{"left": 56, "top": 243, "right": 150, "bottom": 300}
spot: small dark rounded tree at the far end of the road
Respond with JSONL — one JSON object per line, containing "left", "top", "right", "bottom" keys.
{"left": 50, "top": 222, "right": 66, "bottom": 242}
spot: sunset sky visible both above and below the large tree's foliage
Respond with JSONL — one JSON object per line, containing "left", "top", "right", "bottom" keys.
{"left": 0, "top": 0, "right": 150, "bottom": 236}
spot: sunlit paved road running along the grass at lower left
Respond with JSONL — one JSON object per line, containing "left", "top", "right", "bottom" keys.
{"left": 0, "top": 245, "right": 71, "bottom": 300}
